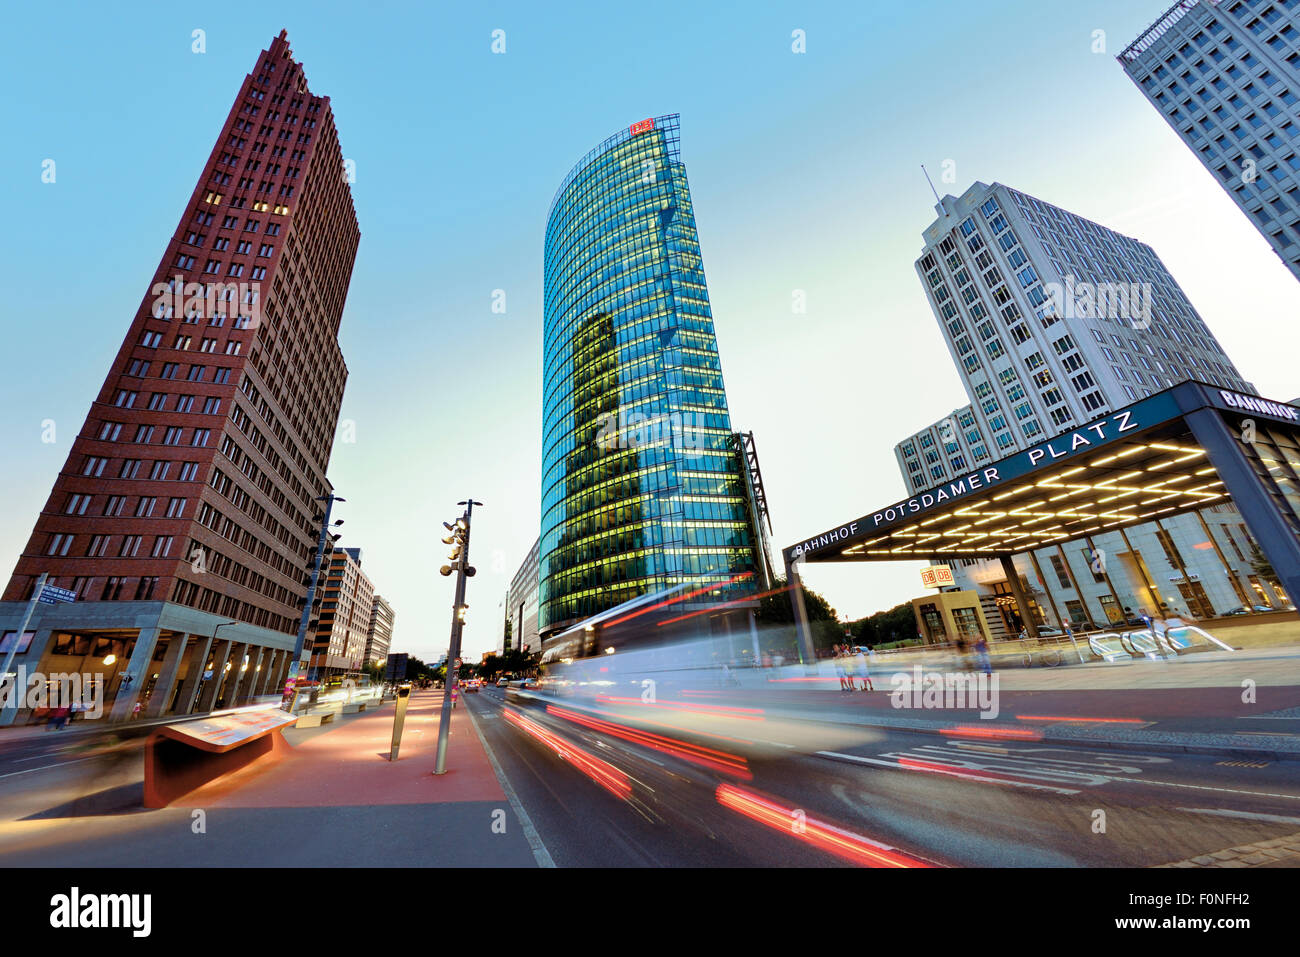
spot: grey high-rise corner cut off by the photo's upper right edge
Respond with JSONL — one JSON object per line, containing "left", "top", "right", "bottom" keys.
{"left": 1118, "top": 0, "right": 1300, "bottom": 278}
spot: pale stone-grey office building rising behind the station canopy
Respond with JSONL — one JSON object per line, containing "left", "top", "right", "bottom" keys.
{"left": 894, "top": 183, "right": 1287, "bottom": 633}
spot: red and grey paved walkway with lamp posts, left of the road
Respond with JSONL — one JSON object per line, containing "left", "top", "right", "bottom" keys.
{"left": 0, "top": 692, "right": 546, "bottom": 867}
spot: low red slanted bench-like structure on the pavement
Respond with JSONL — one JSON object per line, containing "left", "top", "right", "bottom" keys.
{"left": 144, "top": 709, "right": 299, "bottom": 807}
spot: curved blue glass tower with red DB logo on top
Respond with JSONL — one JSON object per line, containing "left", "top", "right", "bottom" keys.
{"left": 538, "top": 114, "right": 758, "bottom": 637}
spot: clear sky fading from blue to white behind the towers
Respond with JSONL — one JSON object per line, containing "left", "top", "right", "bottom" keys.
{"left": 0, "top": 0, "right": 1300, "bottom": 657}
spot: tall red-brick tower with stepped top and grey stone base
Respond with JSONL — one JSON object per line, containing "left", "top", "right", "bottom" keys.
{"left": 0, "top": 33, "right": 360, "bottom": 718}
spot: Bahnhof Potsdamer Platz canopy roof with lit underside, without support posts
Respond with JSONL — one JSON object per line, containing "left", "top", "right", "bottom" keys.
{"left": 784, "top": 382, "right": 1300, "bottom": 563}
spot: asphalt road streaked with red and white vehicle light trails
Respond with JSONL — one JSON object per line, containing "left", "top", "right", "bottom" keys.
{"left": 464, "top": 688, "right": 1300, "bottom": 867}
